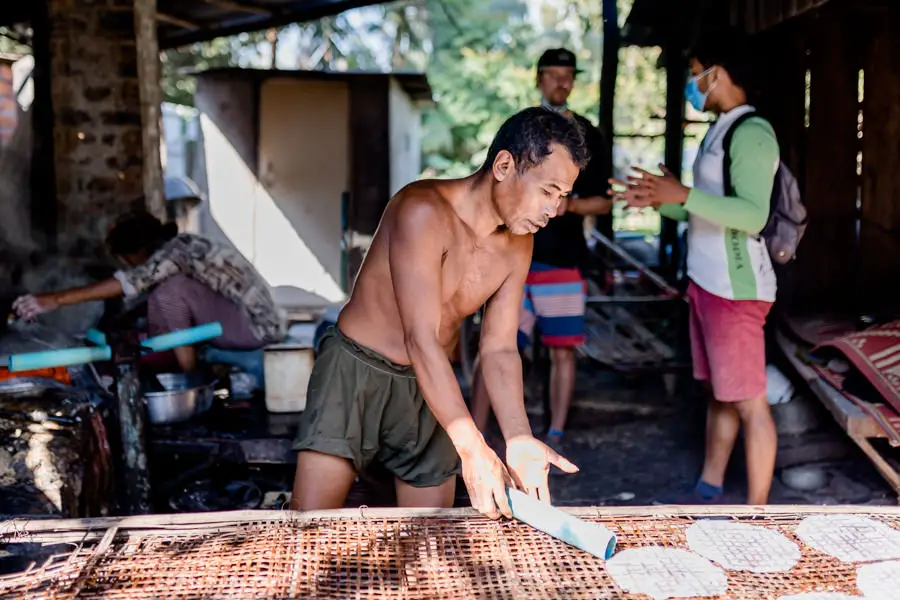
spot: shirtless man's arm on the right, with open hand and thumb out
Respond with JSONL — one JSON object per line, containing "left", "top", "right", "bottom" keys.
{"left": 478, "top": 237, "right": 578, "bottom": 503}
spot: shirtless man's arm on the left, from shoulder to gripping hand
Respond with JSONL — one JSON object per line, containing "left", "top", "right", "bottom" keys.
{"left": 389, "top": 198, "right": 512, "bottom": 518}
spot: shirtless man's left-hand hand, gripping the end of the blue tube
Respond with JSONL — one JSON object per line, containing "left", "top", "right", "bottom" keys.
{"left": 459, "top": 439, "right": 513, "bottom": 519}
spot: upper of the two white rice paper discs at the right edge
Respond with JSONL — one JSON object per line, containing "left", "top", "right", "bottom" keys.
{"left": 797, "top": 515, "right": 900, "bottom": 562}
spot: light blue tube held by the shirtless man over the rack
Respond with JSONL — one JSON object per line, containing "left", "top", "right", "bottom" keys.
{"left": 506, "top": 488, "right": 616, "bottom": 560}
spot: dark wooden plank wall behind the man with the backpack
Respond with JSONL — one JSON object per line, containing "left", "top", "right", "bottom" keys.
{"left": 755, "top": 0, "right": 900, "bottom": 313}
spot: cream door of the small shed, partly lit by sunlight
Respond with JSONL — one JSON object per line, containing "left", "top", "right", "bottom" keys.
{"left": 254, "top": 78, "right": 350, "bottom": 306}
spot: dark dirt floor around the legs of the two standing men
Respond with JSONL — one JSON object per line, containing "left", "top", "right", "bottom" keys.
{"left": 478, "top": 359, "right": 897, "bottom": 506}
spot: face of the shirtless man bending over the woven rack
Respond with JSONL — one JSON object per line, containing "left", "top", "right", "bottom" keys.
{"left": 494, "top": 144, "right": 579, "bottom": 235}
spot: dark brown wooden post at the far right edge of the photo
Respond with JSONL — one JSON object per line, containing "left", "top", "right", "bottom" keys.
{"left": 860, "top": 4, "right": 900, "bottom": 311}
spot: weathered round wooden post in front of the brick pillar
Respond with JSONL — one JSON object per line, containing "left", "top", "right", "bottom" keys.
{"left": 134, "top": 0, "right": 167, "bottom": 221}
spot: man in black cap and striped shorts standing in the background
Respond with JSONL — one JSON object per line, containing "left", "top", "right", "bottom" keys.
{"left": 472, "top": 48, "right": 612, "bottom": 443}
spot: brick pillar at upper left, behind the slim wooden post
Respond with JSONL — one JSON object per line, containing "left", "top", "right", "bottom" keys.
{"left": 48, "top": 0, "right": 143, "bottom": 260}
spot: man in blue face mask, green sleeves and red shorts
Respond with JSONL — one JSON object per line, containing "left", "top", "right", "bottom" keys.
{"left": 612, "top": 32, "right": 779, "bottom": 504}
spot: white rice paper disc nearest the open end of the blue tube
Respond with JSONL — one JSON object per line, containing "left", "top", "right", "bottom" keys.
{"left": 606, "top": 546, "right": 728, "bottom": 600}
